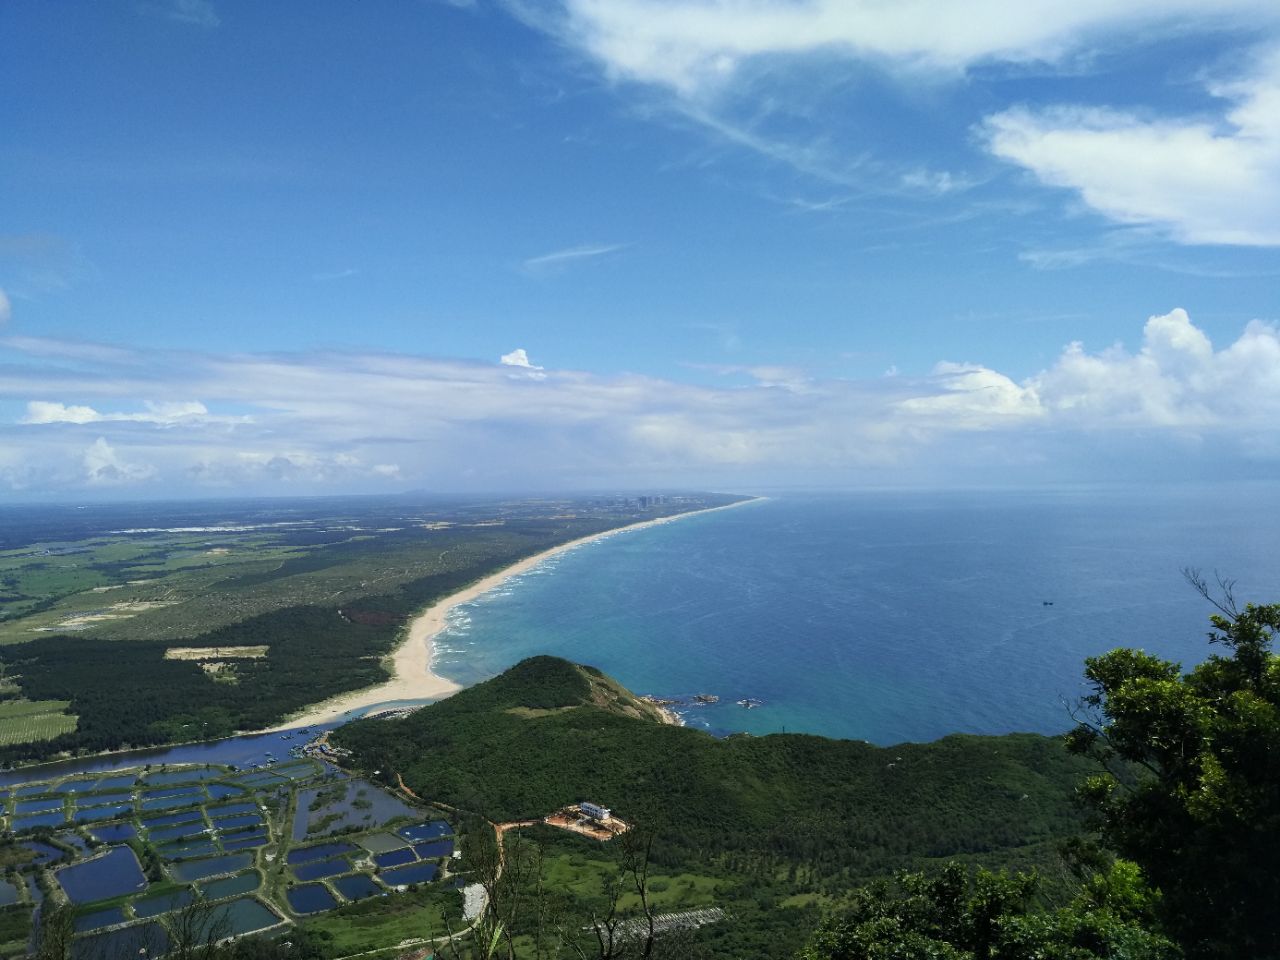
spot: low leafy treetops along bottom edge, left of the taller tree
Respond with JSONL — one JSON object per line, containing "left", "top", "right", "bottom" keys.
{"left": 800, "top": 861, "right": 1178, "bottom": 960}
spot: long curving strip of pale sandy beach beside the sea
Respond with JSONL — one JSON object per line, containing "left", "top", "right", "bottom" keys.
{"left": 268, "top": 497, "right": 764, "bottom": 732}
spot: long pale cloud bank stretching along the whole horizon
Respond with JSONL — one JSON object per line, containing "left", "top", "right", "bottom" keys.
{"left": 0, "top": 310, "right": 1280, "bottom": 495}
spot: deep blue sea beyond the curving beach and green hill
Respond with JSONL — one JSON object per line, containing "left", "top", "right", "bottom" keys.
{"left": 435, "top": 486, "right": 1280, "bottom": 744}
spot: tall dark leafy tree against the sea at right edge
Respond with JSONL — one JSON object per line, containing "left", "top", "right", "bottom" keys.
{"left": 1070, "top": 571, "right": 1280, "bottom": 959}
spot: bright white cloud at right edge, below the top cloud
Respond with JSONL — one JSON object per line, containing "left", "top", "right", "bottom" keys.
{"left": 983, "top": 52, "right": 1280, "bottom": 246}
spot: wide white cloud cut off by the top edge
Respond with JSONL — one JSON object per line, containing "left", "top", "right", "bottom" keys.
{"left": 535, "top": 0, "right": 1277, "bottom": 99}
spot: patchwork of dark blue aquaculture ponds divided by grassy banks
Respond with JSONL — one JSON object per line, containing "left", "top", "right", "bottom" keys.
{"left": 0, "top": 742, "right": 461, "bottom": 960}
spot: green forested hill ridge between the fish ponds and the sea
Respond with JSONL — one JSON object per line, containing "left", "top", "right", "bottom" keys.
{"left": 334, "top": 657, "right": 1092, "bottom": 886}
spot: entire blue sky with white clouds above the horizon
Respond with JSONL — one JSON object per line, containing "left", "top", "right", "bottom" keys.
{"left": 0, "top": 0, "right": 1280, "bottom": 502}
